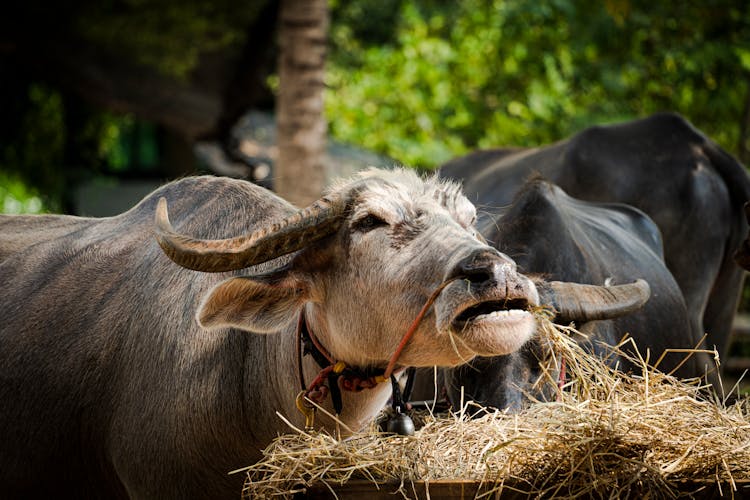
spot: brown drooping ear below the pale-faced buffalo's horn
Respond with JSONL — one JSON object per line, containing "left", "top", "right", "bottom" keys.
{"left": 196, "top": 276, "right": 309, "bottom": 333}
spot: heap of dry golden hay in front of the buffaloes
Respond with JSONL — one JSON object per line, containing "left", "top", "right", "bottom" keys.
{"left": 238, "top": 319, "right": 750, "bottom": 498}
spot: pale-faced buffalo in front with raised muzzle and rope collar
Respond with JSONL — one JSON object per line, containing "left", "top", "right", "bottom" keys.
{"left": 0, "top": 170, "right": 648, "bottom": 498}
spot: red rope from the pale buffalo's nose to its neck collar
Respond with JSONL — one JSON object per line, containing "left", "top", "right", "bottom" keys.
{"left": 297, "top": 276, "right": 460, "bottom": 418}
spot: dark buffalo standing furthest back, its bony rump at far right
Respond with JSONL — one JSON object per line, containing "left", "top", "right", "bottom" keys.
{"left": 441, "top": 113, "right": 750, "bottom": 362}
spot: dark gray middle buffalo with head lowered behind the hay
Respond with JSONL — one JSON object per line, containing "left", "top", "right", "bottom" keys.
{"left": 444, "top": 179, "right": 717, "bottom": 410}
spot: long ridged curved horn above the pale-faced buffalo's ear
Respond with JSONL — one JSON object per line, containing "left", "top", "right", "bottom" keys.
{"left": 155, "top": 194, "right": 348, "bottom": 273}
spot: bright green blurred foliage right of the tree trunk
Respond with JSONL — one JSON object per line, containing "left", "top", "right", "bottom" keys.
{"left": 326, "top": 0, "right": 750, "bottom": 166}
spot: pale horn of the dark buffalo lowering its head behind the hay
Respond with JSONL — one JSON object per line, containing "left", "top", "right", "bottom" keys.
{"left": 537, "top": 279, "right": 651, "bottom": 323}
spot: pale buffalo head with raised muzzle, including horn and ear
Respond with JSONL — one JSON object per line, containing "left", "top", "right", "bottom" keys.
{"left": 157, "top": 170, "right": 539, "bottom": 374}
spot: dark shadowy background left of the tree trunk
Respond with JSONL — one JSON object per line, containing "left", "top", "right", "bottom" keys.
{"left": 0, "top": 0, "right": 278, "bottom": 212}
